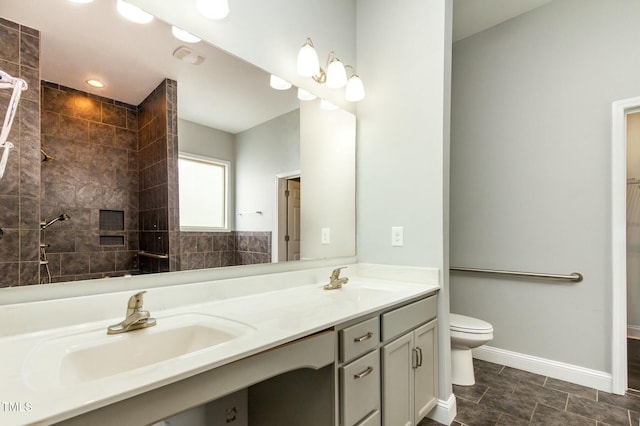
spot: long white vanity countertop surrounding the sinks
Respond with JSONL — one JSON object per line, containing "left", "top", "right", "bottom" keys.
{"left": 0, "top": 265, "right": 439, "bottom": 425}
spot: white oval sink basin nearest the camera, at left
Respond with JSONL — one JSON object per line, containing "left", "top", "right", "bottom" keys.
{"left": 23, "top": 313, "right": 254, "bottom": 389}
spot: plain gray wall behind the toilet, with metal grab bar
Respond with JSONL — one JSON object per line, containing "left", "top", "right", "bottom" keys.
{"left": 451, "top": 0, "right": 640, "bottom": 372}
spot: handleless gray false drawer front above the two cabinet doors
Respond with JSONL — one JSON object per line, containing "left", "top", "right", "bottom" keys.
{"left": 381, "top": 294, "right": 438, "bottom": 341}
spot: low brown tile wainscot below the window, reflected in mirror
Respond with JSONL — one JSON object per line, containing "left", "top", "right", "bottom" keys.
{"left": 180, "top": 231, "right": 271, "bottom": 270}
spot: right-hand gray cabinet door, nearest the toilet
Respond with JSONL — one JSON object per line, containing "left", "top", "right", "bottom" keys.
{"left": 413, "top": 320, "right": 438, "bottom": 424}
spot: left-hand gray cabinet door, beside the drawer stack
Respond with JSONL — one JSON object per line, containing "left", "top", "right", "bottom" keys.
{"left": 382, "top": 332, "right": 413, "bottom": 426}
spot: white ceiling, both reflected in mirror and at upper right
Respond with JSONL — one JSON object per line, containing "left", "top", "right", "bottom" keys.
{"left": 0, "top": 0, "right": 551, "bottom": 133}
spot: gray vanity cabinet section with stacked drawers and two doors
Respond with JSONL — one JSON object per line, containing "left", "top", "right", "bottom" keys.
{"left": 337, "top": 294, "right": 438, "bottom": 426}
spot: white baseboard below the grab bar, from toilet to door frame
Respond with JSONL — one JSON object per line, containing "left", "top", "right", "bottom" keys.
{"left": 473, "top": 345, "right": 613, "bottom": 392}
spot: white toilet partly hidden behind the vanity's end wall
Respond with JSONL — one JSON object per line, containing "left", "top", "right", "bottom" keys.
{"left": 449, "top": 314, "right": 493, "bottom": 386}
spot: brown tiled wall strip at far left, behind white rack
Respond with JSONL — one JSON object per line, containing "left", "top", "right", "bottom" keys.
{"left": 0, "top": 18, "right": 40, "bottom": 287}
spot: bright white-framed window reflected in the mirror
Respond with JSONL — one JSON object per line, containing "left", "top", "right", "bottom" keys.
{"left": 178, "top": 154, "right": 229, "bottom": 231}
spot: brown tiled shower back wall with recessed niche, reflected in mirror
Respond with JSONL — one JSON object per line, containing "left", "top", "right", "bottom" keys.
{"left": 40, "top": 82, "right": 139, "bottom": 282}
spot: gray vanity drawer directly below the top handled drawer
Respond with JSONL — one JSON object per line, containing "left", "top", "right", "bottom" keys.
{"left": 340, "top": 351, "right": 380, "bottom": 426}
